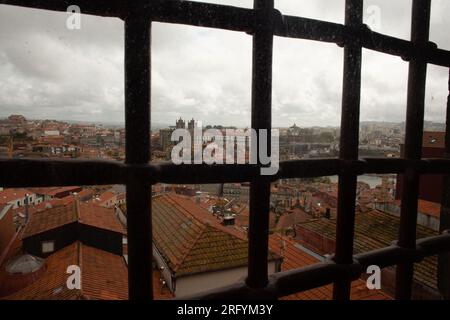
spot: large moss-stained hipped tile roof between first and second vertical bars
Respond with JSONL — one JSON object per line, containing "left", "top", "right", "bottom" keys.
{"left": 152, "top": 194, "right": 278, "bottom": 275}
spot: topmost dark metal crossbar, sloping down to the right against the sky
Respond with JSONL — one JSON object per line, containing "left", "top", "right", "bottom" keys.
{"left": 0, "top": 0, "right": 450, "bottom": 67}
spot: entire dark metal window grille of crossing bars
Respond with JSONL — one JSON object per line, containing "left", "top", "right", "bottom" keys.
{"left": 0, "top": 0, "right": 450, "bottom": 300}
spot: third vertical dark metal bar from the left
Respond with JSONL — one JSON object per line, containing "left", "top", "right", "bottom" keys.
{"left": 333, "top": 0, "right": 363, "bottom": 300}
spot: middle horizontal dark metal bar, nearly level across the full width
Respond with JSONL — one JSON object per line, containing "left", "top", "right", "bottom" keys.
{"left": 4, "top": 158, "right": 450, "bottom": 188}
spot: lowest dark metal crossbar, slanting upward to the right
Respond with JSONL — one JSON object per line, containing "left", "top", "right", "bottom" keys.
{"left": 183, "top": 230, "right": 450, "bottom": 300}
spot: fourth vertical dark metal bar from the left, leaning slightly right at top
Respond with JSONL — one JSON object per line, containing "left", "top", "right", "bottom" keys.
{"left": 395, "top": 0, "right": 431, "bottom": 300}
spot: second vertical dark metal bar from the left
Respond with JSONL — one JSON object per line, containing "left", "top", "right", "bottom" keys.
{"left": 246, "top": 0, "right": 274, "bottom": 288}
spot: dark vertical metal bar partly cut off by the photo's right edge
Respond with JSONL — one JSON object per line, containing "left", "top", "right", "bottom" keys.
{"left": 437, "top": 69, "right": 450, "bottom": 300}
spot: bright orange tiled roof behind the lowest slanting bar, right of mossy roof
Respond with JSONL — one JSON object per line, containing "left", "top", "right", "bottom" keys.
{"left": 269, "top": 234, "right": 391, "bottom": 300}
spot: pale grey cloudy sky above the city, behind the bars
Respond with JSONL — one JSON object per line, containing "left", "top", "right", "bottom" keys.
{"left": 0, "top": 0, "right": 450, "bottom": 126}
